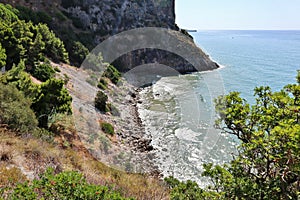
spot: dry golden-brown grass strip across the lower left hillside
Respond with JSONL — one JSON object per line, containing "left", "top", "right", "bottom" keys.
{"left": 0, "top": 128, "right": 169, "bottom": 200}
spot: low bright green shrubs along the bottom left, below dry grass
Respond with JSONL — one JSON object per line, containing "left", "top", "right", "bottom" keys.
{"left": 6, "top": 168, "right": 132, "bottom": 200}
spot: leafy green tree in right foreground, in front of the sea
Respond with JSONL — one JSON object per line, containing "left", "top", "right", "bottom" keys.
{"left": 199, "top": 73, "right": 300, "bottom": 199}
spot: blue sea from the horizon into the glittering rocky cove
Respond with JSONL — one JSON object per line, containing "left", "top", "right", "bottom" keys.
{"left": 139, "top": 30, "right": 300, "bottom": 186}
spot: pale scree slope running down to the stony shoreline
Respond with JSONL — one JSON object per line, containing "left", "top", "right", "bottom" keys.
{"left": 56, "top": 65, "right": 160, "bottom": 177}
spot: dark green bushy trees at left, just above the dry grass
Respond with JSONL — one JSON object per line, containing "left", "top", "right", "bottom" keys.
{"left": 0, "top": 62, "right": 72, "bottom": 128}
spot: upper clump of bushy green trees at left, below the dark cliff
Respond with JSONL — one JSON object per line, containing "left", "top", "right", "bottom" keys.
{"left": 0, "top": 4, "right": 68, "bottom": 72}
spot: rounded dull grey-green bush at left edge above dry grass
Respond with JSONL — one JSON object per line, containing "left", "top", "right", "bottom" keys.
{"left": 0, "top": 83, "right": 38, "bottom": 133}
